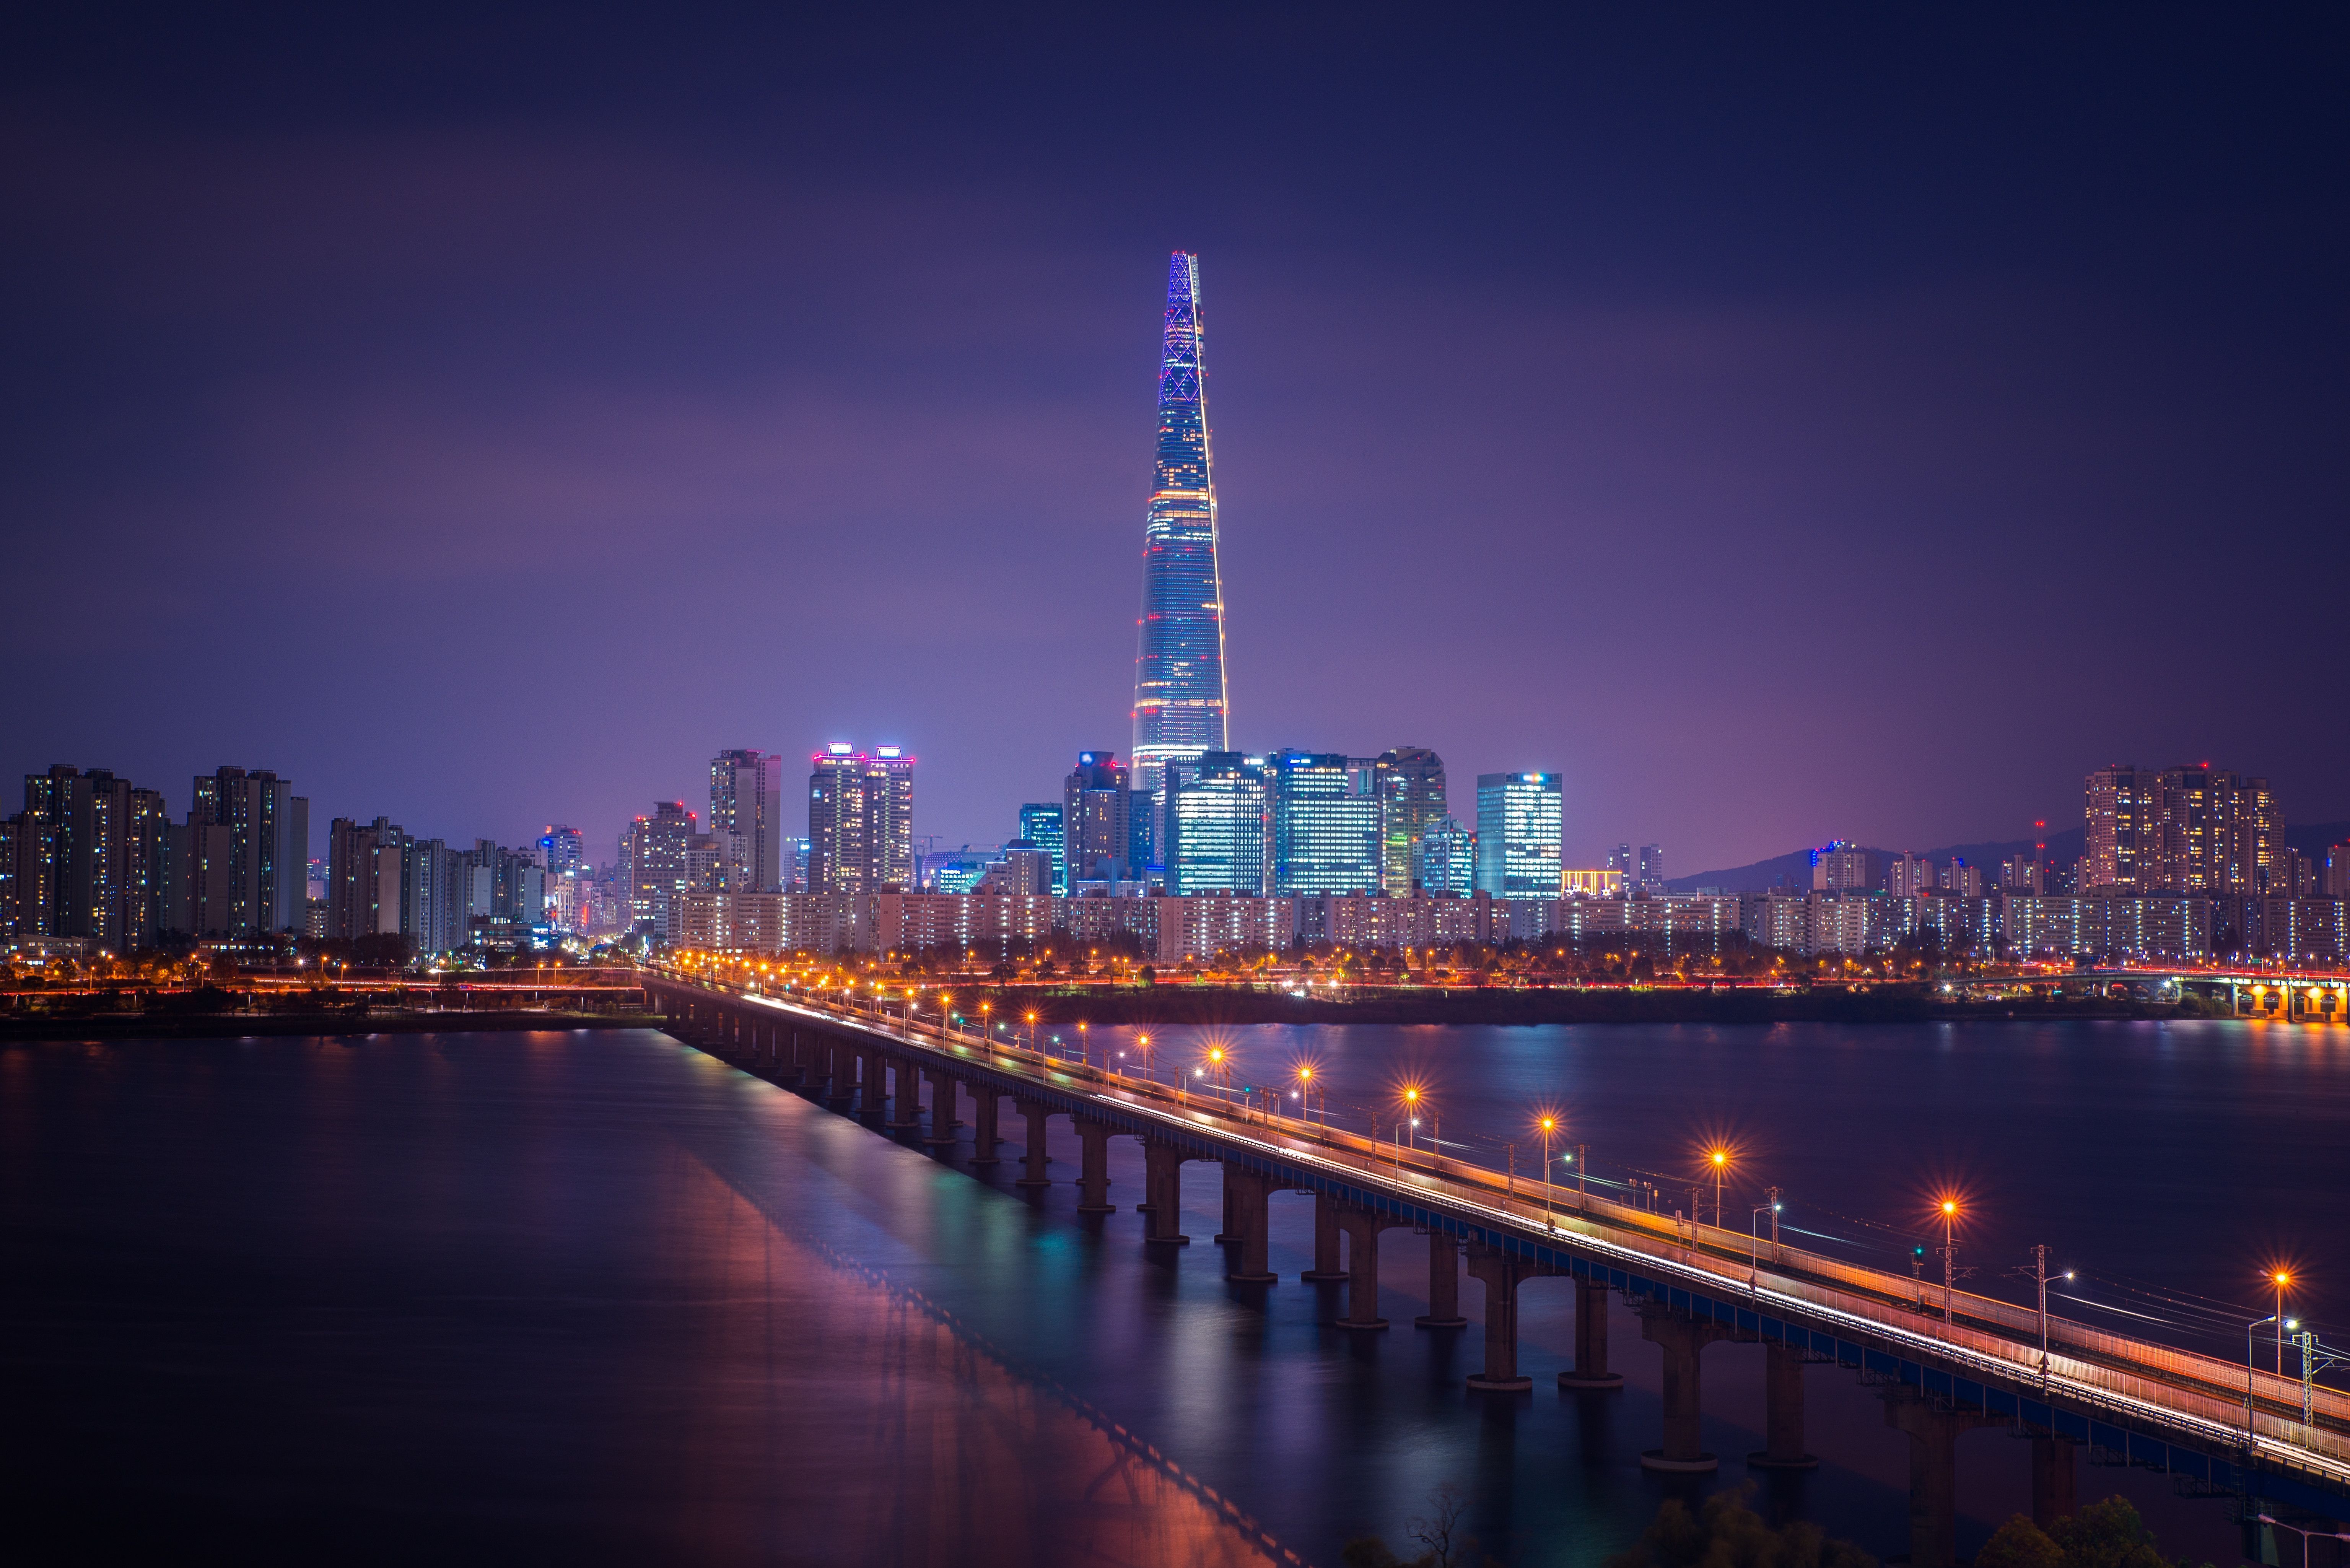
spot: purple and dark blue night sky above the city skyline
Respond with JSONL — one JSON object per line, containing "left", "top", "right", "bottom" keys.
{"left": 0, "top": 5, "right": 2350, "bottom": 875}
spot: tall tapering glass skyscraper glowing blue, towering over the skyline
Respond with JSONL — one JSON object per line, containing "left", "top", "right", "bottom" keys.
{"left": 1130, "top": 252, "right": 1224, "bottom": 792}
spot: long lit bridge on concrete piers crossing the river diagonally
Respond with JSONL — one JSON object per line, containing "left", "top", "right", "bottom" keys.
{"left": 641, "top": 969, "right": 2350, "bottom": 1568}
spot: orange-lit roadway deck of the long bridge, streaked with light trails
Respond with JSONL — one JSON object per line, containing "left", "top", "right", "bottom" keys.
{"left": 672, "top": 973, "right": 2350, "bottom": 1462}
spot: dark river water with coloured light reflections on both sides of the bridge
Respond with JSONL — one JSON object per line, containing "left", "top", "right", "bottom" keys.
{"left": 0, "top": 1023, "right": 2350, "bottom": 1563}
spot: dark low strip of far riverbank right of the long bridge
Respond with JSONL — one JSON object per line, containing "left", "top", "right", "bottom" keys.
{"left": 959, "top": 985, "right": 2207, "bottom": 1025}
